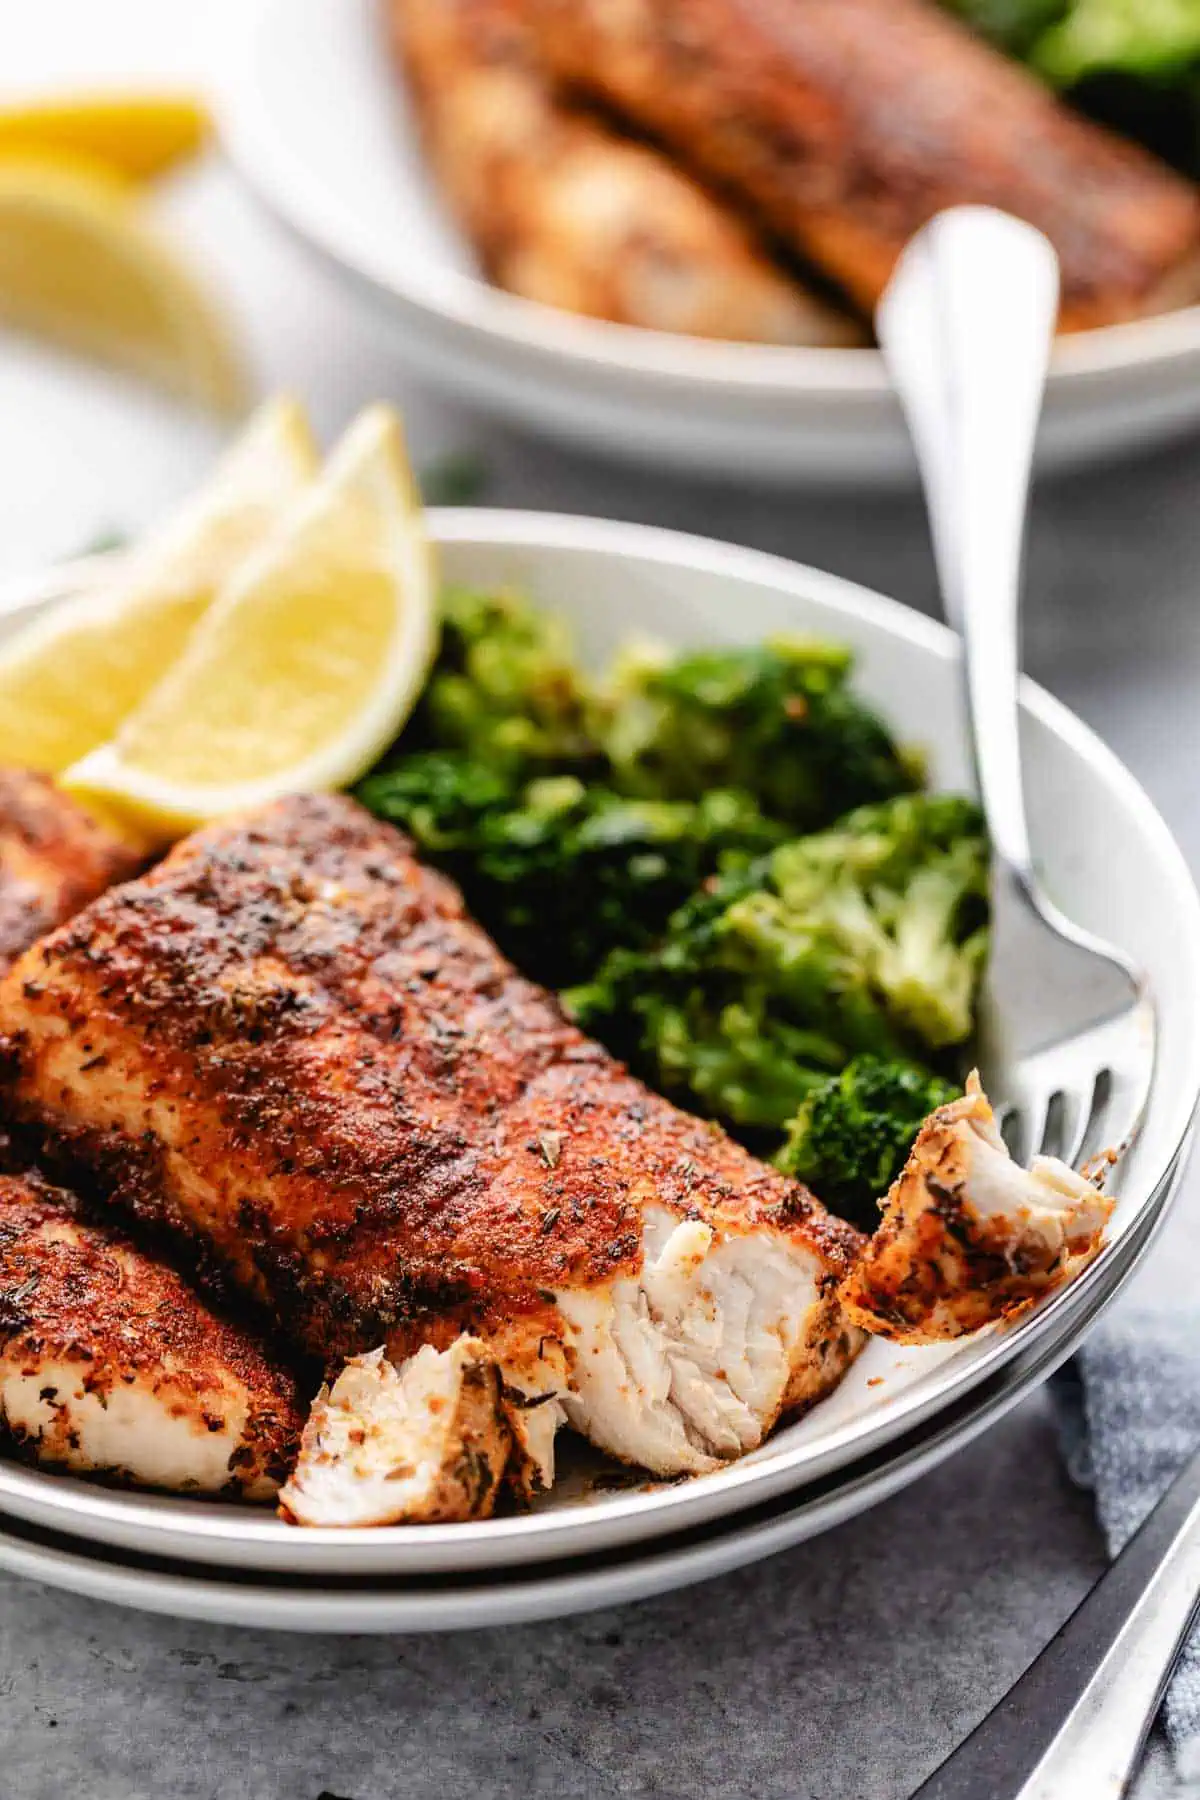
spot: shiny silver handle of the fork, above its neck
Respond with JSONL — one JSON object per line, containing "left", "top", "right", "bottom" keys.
{"left": 876, "top": 207, "right": 1058, "bottom": 878}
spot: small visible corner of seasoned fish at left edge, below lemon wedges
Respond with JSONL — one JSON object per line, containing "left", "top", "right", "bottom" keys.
{"left": 0, "top": 769, "right": 146, "bottom": 974}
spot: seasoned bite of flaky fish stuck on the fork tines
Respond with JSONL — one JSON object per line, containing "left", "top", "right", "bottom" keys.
{"left": 842, "top": 1075, "right": 1114, "bottom": 1343}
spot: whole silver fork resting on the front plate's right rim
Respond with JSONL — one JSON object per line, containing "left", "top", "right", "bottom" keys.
{"left": 876, "top": 207, "right": 1155, "bottom": 1165}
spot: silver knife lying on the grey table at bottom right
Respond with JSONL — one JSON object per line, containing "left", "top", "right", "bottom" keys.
{"left": 914, "top": 1451, "right": 1200, "bottom": 1800}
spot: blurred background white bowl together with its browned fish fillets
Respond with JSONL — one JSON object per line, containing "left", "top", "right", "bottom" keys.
{"left": 225, "top": 0, "right": 1200, "bottom": 482}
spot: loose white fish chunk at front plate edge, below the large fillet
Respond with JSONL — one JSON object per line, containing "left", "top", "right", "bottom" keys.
{"left": 279, "top": 1336, "right": 509, "bottom": 1525}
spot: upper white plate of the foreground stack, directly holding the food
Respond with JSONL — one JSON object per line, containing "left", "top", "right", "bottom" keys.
{"left": 0, "top": 511, "right": 1200, "bottom": 1575}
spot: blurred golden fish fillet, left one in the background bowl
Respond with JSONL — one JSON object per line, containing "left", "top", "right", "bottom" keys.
{"left": 390, "top": 0, "right": 864, "bottom": 346}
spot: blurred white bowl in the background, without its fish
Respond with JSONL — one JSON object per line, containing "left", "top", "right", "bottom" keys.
{"left": 223, "top": 0, "right": 1200, "bottom": 482}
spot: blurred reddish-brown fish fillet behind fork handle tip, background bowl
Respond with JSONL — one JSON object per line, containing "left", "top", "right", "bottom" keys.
{"left": 521, "top": 0, "right": 1200, "bottom": 329}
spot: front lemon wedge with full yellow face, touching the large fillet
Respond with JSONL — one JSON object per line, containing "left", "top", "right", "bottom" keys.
{"left": 63, "top": 407, "right": 437, "bottom": 842}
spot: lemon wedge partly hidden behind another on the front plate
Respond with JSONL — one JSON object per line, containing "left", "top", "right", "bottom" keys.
{"left": 0, "top": 400, "right": 317, "bottom": 774}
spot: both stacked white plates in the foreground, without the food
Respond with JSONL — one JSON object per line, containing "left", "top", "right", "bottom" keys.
{"left": 0, "top": 511, "right": 1200, "bottom": 1631}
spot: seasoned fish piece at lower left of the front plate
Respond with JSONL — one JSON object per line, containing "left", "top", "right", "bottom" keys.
{"left": 0, "top": 1175, "right": 300, "bottom": 1499}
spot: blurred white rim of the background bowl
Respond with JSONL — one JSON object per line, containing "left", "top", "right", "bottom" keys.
{"left": 219, "top": 0, "right": 1200, "bottom": 405}
